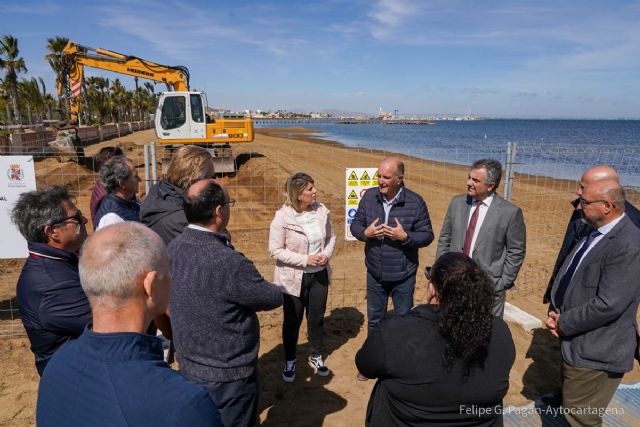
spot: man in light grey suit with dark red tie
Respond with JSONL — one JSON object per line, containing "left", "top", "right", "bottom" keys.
{"left": 436, "top": 159, "right": 526, "bottom": 316}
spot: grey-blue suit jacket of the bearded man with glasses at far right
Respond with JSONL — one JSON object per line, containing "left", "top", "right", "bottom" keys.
{"left": 550, "top": 215, "right": 640, "bottom": 373}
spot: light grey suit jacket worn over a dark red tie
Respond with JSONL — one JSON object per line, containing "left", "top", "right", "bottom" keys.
{"left": 436, "top": 194, "right": 526, "bottom": 290}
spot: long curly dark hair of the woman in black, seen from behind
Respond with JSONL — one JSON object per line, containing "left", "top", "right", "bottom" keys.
{"left": 431, "top": 252, "right": 494, "bottom": 375}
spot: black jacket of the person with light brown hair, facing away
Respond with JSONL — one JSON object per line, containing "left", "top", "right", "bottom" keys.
{"left": 140, "top": 180, "right": 189, "bottom": 245}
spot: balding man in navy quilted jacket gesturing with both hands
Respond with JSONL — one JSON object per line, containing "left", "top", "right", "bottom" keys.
{"left": 351, "top": 157, "right": 433, "bottom": 330}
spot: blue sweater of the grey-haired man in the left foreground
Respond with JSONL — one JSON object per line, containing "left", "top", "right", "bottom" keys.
{"left": 36, "top": 328, "right": 222, "bottom": 427}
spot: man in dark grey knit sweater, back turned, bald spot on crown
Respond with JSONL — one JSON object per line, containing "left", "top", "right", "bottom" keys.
{"left": 169, "top": 179, "right": 282, "bottom": 427}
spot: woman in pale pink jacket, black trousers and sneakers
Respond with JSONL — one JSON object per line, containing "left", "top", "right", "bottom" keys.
{"left": 269, "top": 172, "right": 336, "bottom": 382}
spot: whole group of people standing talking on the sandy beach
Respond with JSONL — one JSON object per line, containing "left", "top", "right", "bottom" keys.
{"left": 12, "top": 146, "right": 640, "bottom": 426}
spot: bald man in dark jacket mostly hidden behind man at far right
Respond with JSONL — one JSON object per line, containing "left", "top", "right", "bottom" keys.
{"left": 542, "top": 165, "right": 640, "bottom": 304}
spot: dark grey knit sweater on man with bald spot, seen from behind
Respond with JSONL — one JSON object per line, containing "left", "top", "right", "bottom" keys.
{"left": 169, "top": 228, "right": 282, "bottom": 382}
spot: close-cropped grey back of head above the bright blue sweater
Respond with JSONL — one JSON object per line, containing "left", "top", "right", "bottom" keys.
{"left": 79, "top": 222, "right": 169, "bottom": 306}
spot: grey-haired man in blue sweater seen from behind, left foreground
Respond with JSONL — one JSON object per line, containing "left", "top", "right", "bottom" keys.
{"left": 36, "top": 222, "right": 221, "bottom": 427}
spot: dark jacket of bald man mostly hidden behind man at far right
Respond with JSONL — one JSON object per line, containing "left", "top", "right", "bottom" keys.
{"left": 542, "top": 199, "right": 640, "bottom": 304}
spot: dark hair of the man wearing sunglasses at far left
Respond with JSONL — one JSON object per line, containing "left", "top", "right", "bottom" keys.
{"left": 11, "top": 185, "right": 73, "bottom": 243}
